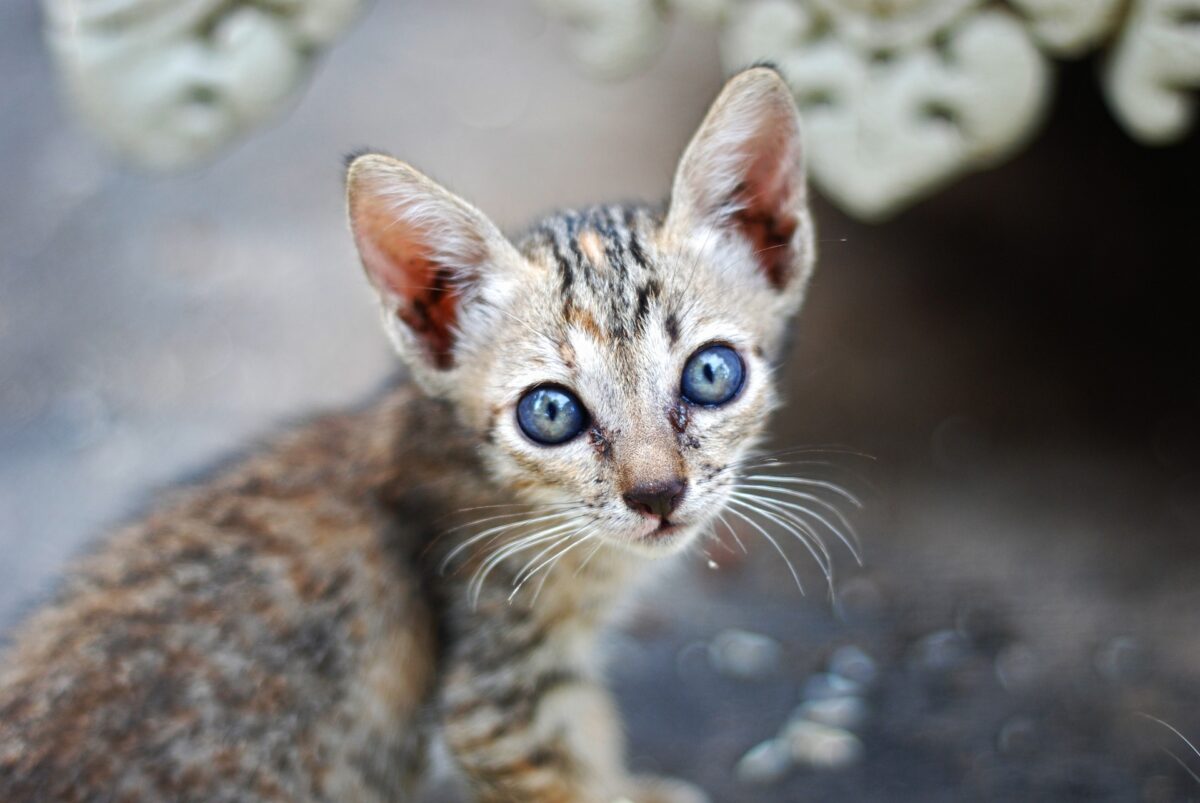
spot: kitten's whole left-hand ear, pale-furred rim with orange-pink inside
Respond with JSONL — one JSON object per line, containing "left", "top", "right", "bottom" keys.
{"left": 346, "top": 154, "right": 520, "bottom": 384}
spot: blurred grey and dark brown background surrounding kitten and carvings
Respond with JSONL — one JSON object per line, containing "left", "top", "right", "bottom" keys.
{"left": 0, "top": 0, "right": 1200, "bottom": 803}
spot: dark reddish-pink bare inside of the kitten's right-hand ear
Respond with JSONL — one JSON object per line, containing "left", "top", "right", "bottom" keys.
{"left": 732, "top": 133, "right": 798, "bottom": 289}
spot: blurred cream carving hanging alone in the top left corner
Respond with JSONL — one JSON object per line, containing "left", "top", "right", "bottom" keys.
{"left": 44, "top": 0, "right": 361, "bottom": 169}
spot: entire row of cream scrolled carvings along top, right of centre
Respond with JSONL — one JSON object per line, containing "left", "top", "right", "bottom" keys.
{"left": 541, "top": 0, "right": 1200, "bottom": 218}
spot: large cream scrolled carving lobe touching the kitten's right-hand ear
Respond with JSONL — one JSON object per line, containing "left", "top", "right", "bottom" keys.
{"left": 726, "top": 0, "right": 1046, "bottom": 218}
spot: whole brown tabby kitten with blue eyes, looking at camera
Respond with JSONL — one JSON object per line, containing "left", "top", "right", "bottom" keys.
{"left": 0, "top": 67, "right": 814, "bottom": 803}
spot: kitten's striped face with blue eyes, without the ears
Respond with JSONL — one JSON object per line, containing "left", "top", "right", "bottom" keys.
{"left": 456, "top": 208, "right": 785, "bottom": 551}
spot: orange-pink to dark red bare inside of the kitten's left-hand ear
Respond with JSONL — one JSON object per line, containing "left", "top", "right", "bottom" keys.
{"left": 355, "top": 210, "right": 461, "bottom": 370}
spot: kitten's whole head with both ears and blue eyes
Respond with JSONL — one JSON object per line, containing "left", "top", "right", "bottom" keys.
{"left": 348, "top": 67, "right": 815, "bottom": 553}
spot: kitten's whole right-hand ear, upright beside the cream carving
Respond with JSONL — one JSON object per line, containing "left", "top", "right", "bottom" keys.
{"left": 667, "top": 67, "right": 815, "bottom": 298}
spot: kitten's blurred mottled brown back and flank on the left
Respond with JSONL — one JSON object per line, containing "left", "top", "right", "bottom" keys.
{"left": 0, "top": 391, "right": 451, "bottom": 801}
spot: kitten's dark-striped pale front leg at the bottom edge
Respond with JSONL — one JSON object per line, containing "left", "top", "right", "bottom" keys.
{"left": 442, "top": 643, "right": 707, "bottom": 803}
